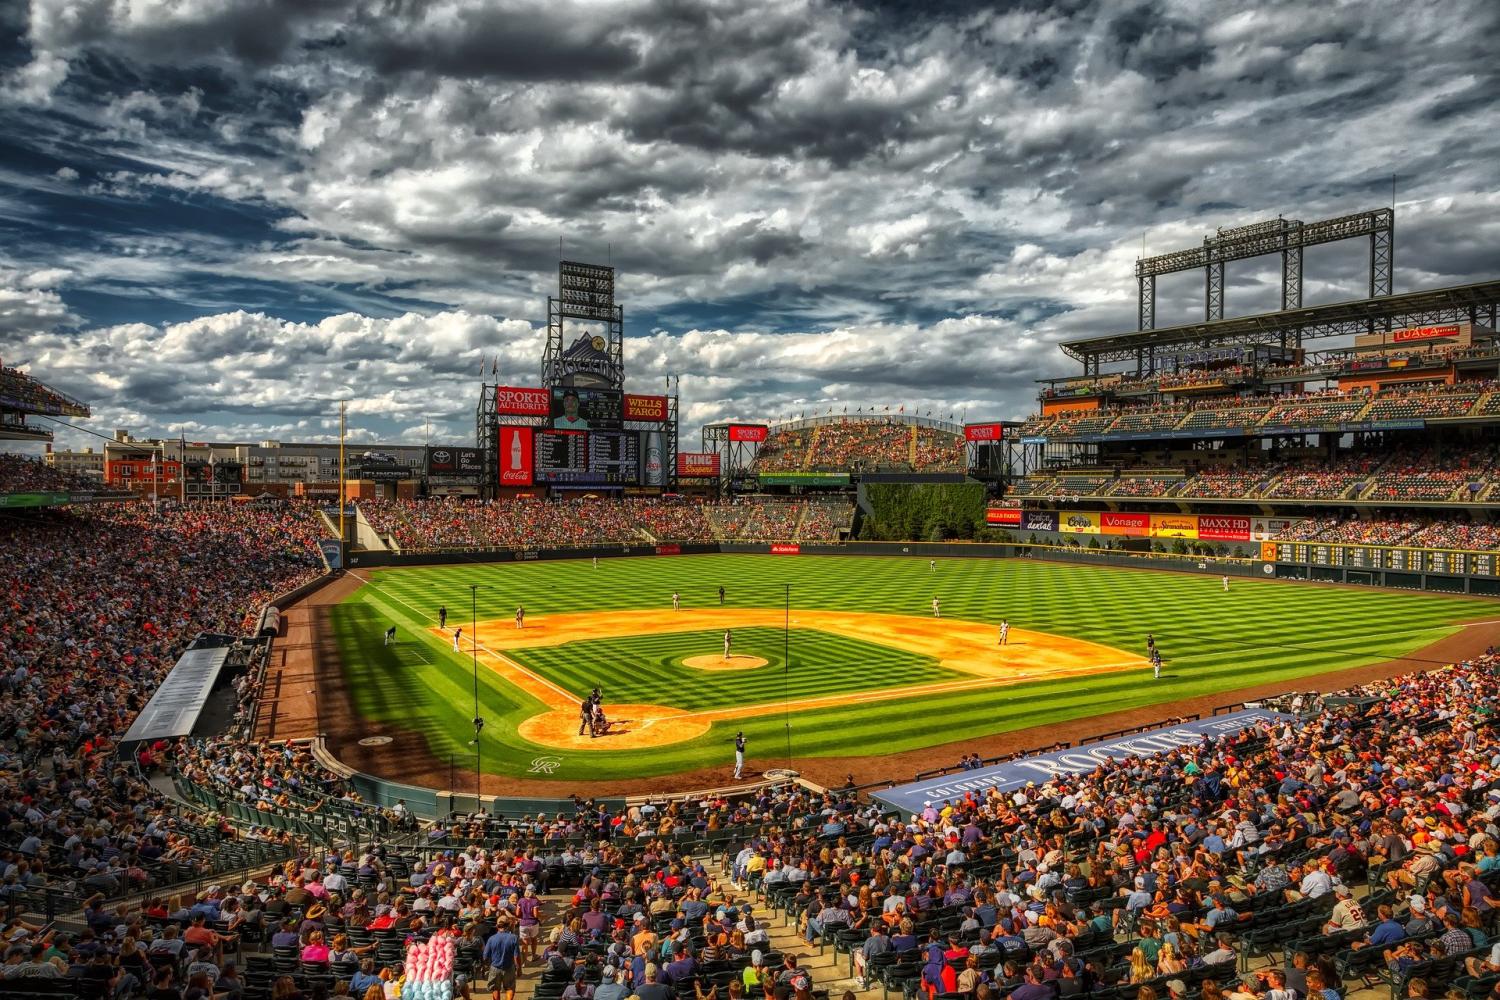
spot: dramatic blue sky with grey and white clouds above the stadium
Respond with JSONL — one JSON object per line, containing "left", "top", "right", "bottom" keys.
{"left": 0, "top": 0, "right": 1500, "bottom": 448}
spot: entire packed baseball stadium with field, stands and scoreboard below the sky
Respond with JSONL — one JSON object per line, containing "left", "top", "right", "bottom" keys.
{"left": 0, "top": 208, "right": 1500, "bottom": 1000}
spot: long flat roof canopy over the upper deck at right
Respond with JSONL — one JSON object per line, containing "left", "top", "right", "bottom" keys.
{"left": 1059, "top": 280, "right": 1500, "bottom": 373}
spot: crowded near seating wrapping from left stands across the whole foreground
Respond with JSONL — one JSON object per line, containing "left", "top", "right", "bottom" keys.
{"left": 0, "top": 504, "right": 1500, "bottom": 1000}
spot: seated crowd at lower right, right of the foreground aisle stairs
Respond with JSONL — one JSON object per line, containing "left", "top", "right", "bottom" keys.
{"left": 734, "top": 651, "right": 1500, "bottom": 1000}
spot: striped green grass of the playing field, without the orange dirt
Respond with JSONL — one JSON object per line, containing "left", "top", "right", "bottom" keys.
{"left": 330, "top": 555, "right": 1500, "bottom": 780}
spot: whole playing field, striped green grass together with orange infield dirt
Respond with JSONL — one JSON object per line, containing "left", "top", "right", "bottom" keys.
{"left": 323, "top": 555, "right": 1496, "bottom": 787}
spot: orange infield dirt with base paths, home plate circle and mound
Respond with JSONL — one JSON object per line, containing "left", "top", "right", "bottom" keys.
{"left": 432, "top": 607, "right": 1149, "bottom": 750}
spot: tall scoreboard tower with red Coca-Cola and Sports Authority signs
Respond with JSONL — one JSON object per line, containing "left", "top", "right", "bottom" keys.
{"left": 474, "top": 261, "right": 678, "bottom": 499}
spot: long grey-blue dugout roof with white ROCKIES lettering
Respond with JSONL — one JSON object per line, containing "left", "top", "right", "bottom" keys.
{"left": 873, "top": 709, "right": 1292, "bottom": 813}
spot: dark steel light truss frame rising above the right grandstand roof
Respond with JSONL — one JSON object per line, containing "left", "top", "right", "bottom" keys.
{"left": 1136, "top": 208, "right": 1397, "bottom": 330}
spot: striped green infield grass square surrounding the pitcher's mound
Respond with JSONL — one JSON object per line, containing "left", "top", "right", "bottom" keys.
{"left": 506, "top": 629, "right": 966, "bottom": 712}
